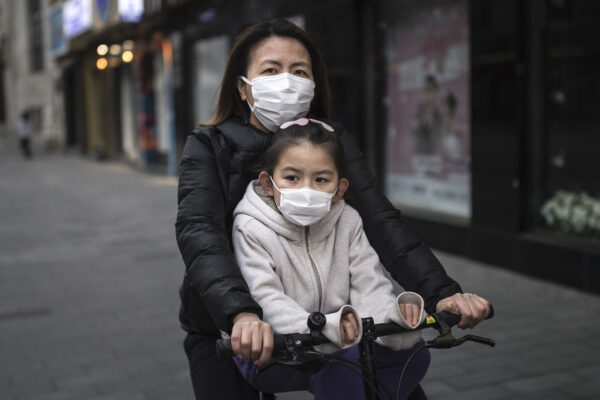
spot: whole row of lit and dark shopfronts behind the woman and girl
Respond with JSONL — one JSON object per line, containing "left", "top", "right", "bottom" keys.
{"left": 3, "top": 0, "right": 600, "bottom": 292}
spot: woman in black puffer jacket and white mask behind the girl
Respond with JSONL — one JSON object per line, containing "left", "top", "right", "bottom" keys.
{"left": 175, "top": 19, "right": 489, "bottom": 399}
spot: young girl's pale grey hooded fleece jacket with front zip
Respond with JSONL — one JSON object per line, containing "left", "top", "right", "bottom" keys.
{"left": 232, "top": 180, "right": 425, "bottom": 352}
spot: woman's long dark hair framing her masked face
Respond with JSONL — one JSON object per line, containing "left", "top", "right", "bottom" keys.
{"left": 205, "top": 18, "right": 331, "bottom": 126}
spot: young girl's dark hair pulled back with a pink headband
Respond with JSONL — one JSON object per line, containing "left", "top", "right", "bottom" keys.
{"left": 258, "top": 120, "right": 346, "bottom": 178}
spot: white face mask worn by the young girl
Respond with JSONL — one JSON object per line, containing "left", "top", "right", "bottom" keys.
{"left": 271, "top": 177, "right": 337, "bottom": 226}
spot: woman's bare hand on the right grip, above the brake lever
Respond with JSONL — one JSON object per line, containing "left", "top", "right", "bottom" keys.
{"left": 435, "top": 293, "right": 490, "bottom": 329}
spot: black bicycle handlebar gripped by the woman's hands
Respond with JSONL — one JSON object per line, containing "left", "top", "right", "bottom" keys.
{"left": 216, "top": 304, "right": 494, "bottom": 358}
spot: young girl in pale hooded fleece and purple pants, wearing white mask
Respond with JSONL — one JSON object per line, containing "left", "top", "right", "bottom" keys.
{"left": 233, "top": 118, "right": 429, "bottom": 399}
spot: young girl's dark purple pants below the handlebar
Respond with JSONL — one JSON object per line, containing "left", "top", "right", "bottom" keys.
{"left": 234, "top": 340, "right": 430, "bottom": 400}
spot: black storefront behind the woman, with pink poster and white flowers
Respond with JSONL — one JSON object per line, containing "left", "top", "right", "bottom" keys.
{"left": 165, "top": 0, "right": 600, "bottom": 291}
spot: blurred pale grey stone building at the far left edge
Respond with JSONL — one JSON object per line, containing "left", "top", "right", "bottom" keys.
{"left": 0, "top": 0, "right": 64, "bottom": 150}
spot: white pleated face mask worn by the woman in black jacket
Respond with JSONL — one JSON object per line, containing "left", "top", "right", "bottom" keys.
{"left": 241, "top": 72, "right": 315, "bottom": 132}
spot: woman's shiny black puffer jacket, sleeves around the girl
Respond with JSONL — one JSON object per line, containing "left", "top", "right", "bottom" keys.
{"left": 175, "top": 118, "right": 461, "bottom": 335}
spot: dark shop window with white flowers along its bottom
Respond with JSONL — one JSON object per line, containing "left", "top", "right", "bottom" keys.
{"left": 538, "top": 0, "right": 600, "bottom": 240}
